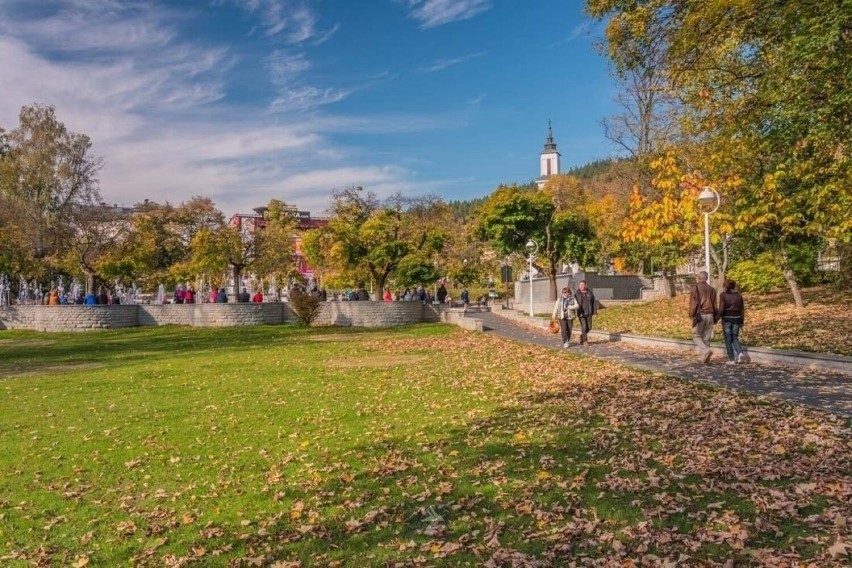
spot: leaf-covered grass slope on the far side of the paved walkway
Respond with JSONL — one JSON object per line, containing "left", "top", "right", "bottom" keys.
{"left": 595, "top": 286, "right": 852, "bottom": 355}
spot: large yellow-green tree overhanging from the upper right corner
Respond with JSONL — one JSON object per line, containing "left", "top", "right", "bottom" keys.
{"left": 587, "top": 0, "right": 852, "bottom": 305}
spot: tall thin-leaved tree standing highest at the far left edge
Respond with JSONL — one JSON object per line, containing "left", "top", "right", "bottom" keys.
{"left": 0, "top": 104, "right": 102, "bottom": 260}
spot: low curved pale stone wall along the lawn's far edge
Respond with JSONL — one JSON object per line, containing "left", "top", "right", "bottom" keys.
{"left": 0, "top": 302, "right": 446, "bottom": 331}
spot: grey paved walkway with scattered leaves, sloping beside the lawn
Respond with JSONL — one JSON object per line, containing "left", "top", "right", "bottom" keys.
{"left": 467, "top": 312, "right": 852, "bottom": 417}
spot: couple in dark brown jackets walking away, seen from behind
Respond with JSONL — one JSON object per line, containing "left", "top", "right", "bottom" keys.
{"left": 689, "top": 271, "right": 745, "bottom": 365}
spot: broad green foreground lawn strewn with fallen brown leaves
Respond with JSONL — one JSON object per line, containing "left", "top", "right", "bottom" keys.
{"left": 0, "top": 324, "right": 852, "bottom": 567}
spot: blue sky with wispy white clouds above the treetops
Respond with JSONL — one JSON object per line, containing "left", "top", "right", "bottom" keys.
{"left": 0, "top": 0, "right": 617, "bottom": 216}
